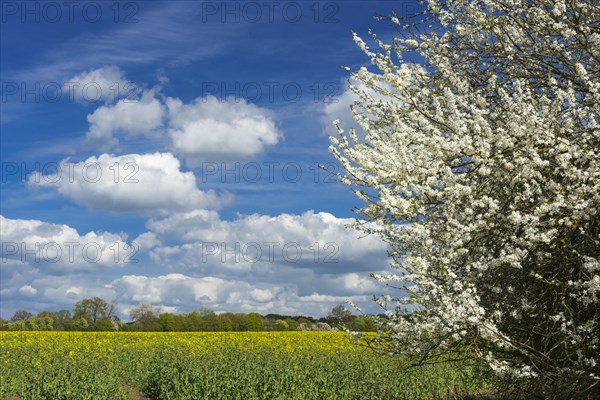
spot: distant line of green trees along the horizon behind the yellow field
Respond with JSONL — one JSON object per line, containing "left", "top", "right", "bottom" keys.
{"left": 0, "top": 297, "right": 375, "bottom": 332}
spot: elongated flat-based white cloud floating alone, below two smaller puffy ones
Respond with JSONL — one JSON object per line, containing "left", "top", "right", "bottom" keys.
{"left": 29, "top": 153, "right": 232, "bottom": 213}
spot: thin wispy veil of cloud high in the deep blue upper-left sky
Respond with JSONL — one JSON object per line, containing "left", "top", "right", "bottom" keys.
{"left": 4, "top": 2, "right": 242, "bottom": 82}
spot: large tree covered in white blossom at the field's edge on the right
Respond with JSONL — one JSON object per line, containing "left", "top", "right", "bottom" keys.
{"left": 330, "top": 0, "right": 600, "bottom": 398}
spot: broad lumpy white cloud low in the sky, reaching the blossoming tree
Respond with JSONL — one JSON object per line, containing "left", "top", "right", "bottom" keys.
{"left": 146, "top": 210, "right": 387, "bottom": 269}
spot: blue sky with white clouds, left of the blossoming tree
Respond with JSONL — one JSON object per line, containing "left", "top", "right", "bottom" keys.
{"left": 0, "top": 1, "right": 418, "bottom": 319}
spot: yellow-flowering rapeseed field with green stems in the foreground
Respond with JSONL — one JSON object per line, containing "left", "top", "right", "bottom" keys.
{"left": 0, "top": 332, "right": 488, "bottom": 400}
